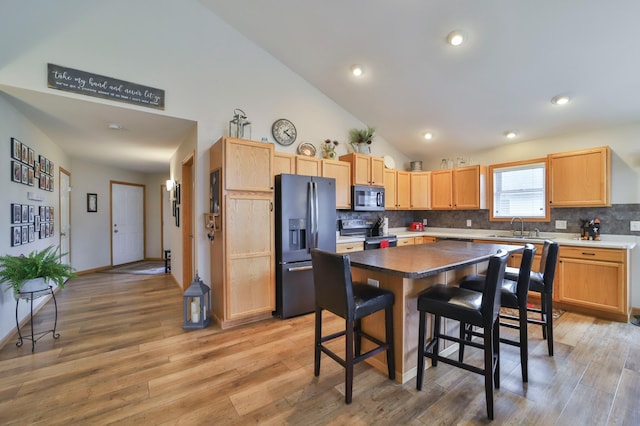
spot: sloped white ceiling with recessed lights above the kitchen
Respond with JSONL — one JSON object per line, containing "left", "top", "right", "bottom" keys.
{"left": 201, "top": 0, "right": 640, "bottom": 158}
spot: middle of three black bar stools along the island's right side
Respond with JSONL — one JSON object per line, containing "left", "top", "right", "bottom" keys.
{"left": 458, "top": 244, "right": 536, "bottom": 382}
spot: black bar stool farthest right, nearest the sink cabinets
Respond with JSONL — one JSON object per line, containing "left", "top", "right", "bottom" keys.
{"left": 504, "top": 240, "right": 560, "bottom": 356}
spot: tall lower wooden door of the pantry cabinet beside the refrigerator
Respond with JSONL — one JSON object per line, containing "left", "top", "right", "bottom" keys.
{"left": 225, "top": 194, "right": 275, "bottom": 320}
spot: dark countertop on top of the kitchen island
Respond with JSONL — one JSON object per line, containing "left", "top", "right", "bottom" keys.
{"left": 349, "top": 241, "right": 524, "bottom": 278}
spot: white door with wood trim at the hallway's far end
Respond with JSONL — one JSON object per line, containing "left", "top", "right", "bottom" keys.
{"left": 111, "top": 183, "right": 144, "bottom": 266}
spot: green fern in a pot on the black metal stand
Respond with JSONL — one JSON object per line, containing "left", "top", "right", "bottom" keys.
{"left": 0, "top": 246, "right": 76, "bottom": 296}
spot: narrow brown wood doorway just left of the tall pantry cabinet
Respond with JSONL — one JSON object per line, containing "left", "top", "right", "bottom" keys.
{"left": 180, "top": 152, "right": 195, "bottom": 289}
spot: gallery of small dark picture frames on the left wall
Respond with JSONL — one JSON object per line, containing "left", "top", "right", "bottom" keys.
{"left": 10, "top": 138, "right": 55, "bottom": 247}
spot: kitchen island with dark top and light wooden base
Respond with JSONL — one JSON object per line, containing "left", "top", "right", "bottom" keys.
{"left": 350, "top": 241, "right": 524, "bottom": 383}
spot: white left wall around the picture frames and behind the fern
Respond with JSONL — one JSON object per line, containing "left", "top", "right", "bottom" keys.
{"left": 0, "top": 93, "right": 70, "bottom": 341}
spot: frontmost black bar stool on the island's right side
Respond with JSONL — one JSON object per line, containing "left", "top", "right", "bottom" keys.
{"left": 416, "top": 250, "right": 509, "bottom": 420}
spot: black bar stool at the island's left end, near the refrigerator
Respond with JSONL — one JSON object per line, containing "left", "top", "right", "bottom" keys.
{"left": 311, "top": 249, "right": 396, "bottom": 404}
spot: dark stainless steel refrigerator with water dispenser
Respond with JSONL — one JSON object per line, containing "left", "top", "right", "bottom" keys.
{"left": 275, "top": 174, "right": 337, "bottom": 318}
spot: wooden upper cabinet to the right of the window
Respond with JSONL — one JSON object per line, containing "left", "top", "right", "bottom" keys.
{"left": 548, "top": 146, "right": 611, "bottom": 207}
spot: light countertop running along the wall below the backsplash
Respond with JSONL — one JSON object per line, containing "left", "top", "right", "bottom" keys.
{"left": 336, "top": 228, "right": 636, "bottom": 250}
